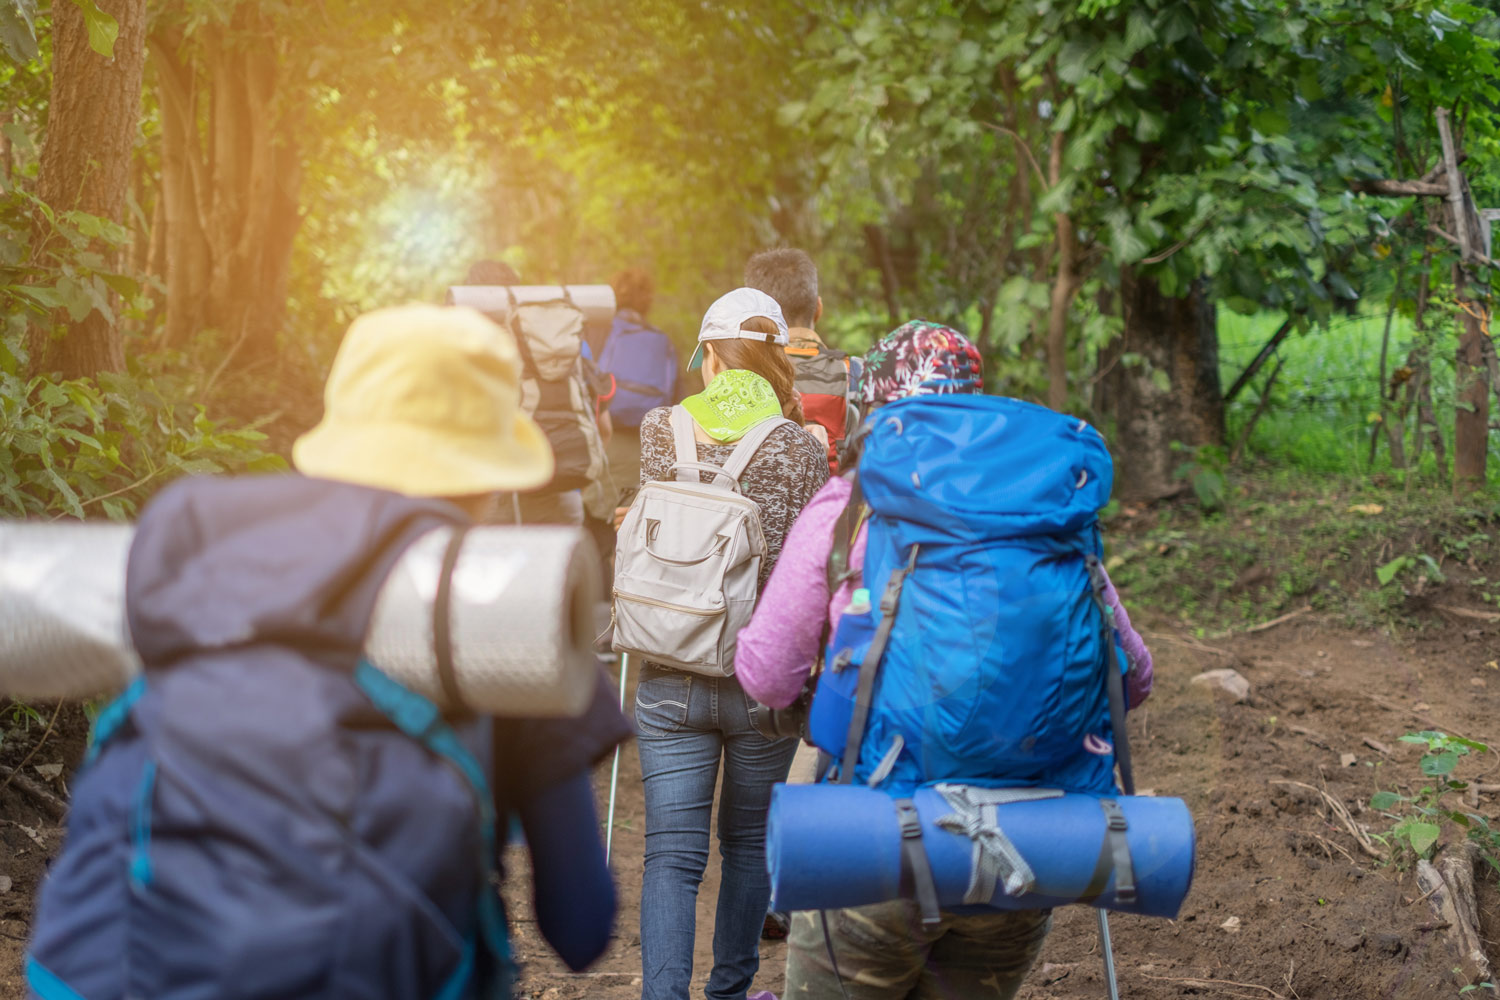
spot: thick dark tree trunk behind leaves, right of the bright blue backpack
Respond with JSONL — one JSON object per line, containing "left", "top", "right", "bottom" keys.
{"left": 1107, "top": 271, "right": 1224, "bottom": 499}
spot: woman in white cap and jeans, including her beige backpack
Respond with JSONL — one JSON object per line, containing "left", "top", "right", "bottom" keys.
{"left": 615, "top": 288, "right": 828, "bottom": 1000}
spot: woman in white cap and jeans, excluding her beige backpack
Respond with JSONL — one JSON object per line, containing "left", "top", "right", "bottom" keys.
{"left": 636, "top": 288, "right": 828, "bottom": 1000}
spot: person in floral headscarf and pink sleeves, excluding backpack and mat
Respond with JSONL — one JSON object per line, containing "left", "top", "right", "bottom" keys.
{"left": 735, "top": 319, "right": 1152, "bottom": 1000}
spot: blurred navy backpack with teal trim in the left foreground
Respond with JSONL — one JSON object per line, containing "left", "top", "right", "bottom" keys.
{"left": 27, "top": 477, "right": 513, "bottom": 1000}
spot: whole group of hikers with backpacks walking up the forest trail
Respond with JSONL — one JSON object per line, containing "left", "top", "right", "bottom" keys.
{"left": 17, "top": 249, "right": 1152, "bottom": 1000}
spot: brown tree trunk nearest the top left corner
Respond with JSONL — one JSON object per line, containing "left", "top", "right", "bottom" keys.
{"left": 30, "top": 0, "right": 146, "bottom": 378}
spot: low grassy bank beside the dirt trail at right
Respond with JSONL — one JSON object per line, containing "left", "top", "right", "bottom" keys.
{"left": 1106, "top": 469, "right": 1500, "bottom": 631}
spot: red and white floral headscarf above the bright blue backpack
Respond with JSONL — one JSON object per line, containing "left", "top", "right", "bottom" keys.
{"left": 858, "top": 319, "right": 984, "bottom": 406}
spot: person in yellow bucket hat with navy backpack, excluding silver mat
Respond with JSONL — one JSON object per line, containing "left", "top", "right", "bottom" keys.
{"left": 27, "top": 306, "right": 630, "bottom": 1000}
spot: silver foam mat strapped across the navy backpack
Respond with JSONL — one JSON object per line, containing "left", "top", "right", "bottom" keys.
{"left": 0, "top": 522, "right": 599, "bottom": 718}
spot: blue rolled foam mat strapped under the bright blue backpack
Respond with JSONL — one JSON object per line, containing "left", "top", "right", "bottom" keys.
{"left": 765, "top": 784, "right": 1196, "bottom": 918}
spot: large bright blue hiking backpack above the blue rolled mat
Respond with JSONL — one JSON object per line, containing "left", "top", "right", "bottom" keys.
{"left": 809, "top": 396, "right": 1128, "bottom": 795}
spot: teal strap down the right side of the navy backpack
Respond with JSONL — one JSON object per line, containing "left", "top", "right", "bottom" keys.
{"left": 354, "top": 660, "right": 515, "bottom": 994}
